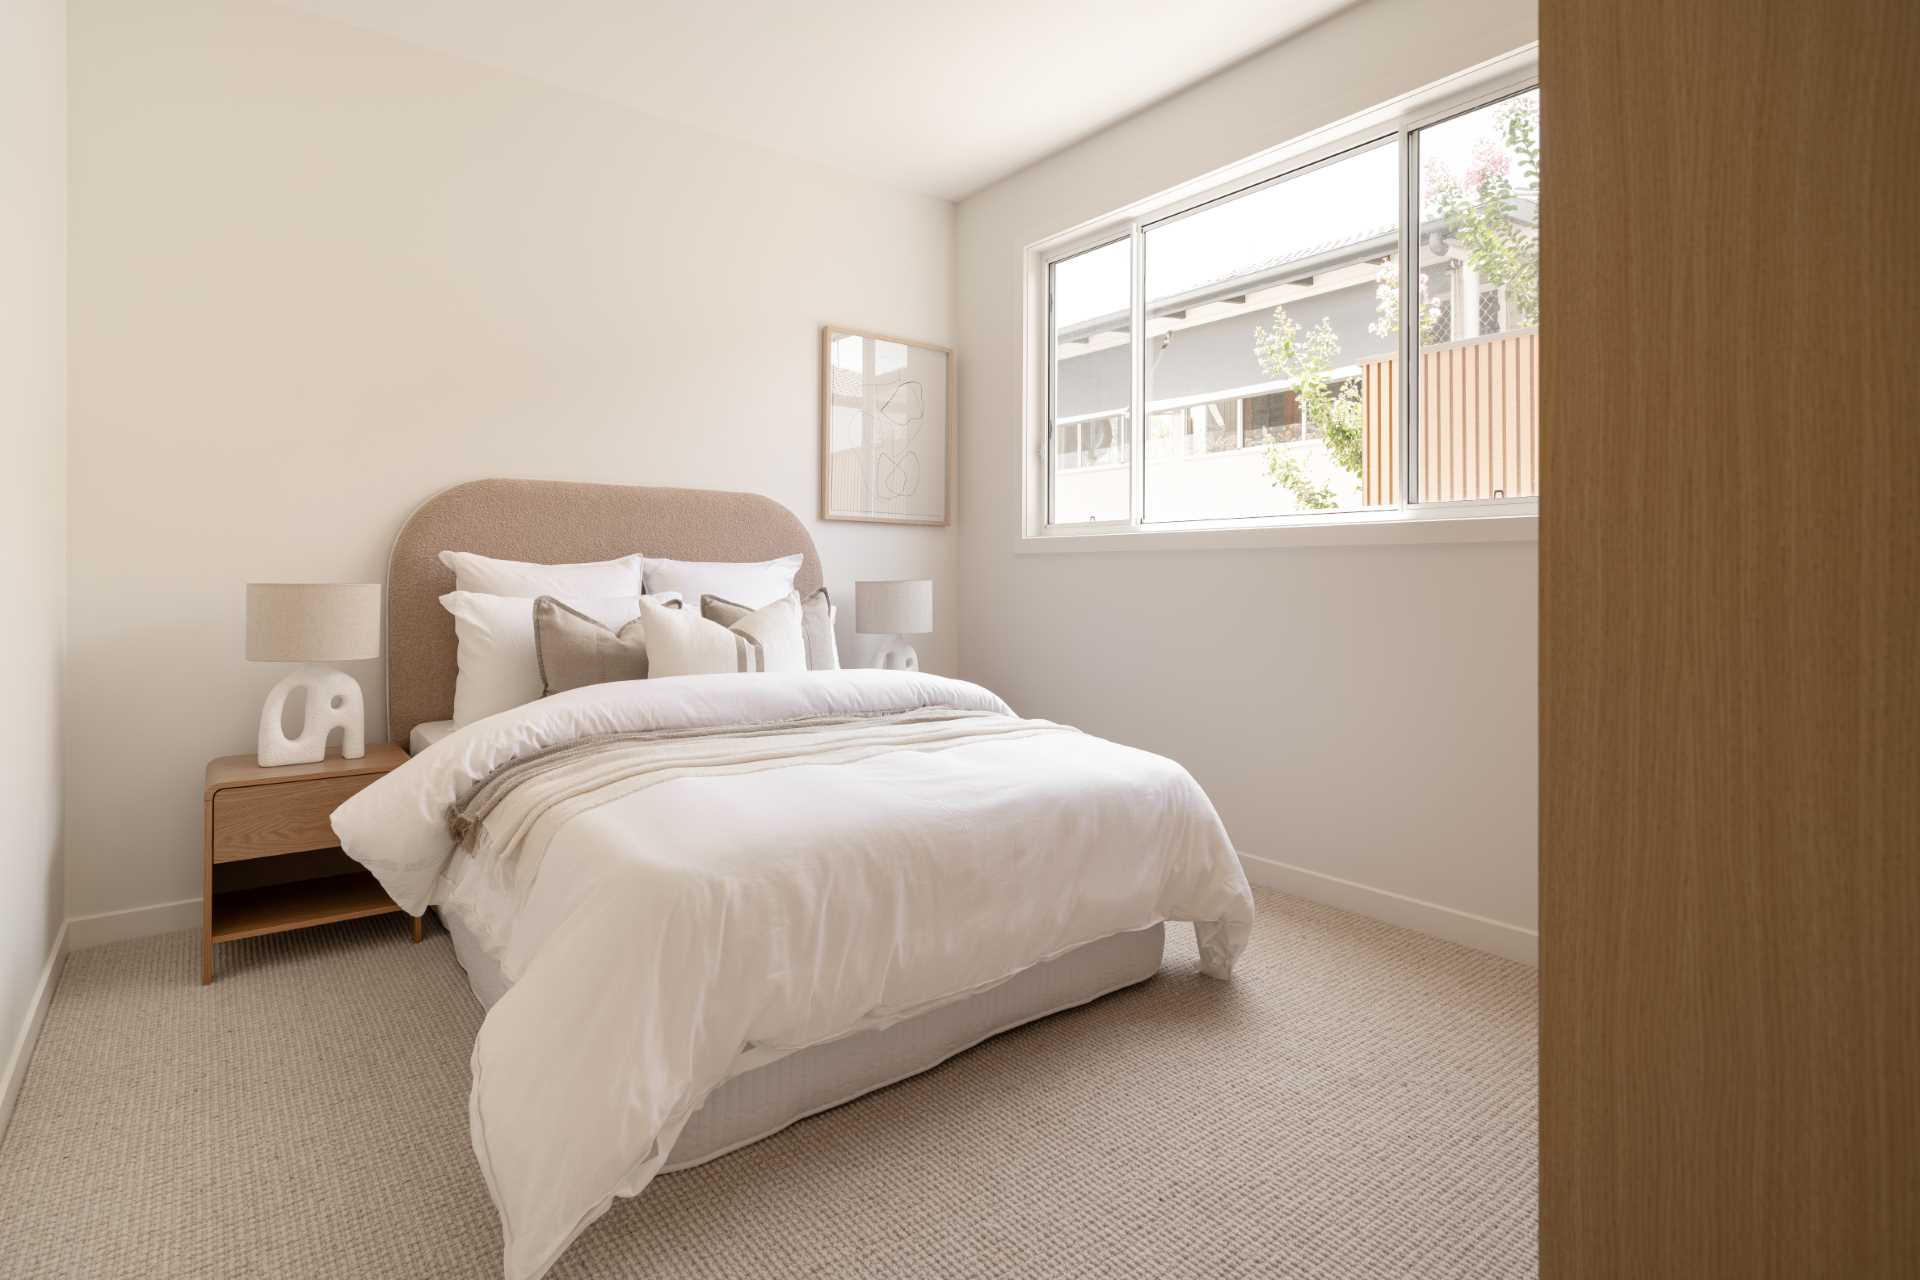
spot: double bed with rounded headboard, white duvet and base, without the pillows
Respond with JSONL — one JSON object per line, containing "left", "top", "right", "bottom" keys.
{"left": 334, "top": 480, "right": 1252, "bottom": 1280}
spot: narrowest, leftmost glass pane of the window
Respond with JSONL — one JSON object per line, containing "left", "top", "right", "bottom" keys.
{"left": 1048, "top": 240, "right": 1133, "bottom": 524}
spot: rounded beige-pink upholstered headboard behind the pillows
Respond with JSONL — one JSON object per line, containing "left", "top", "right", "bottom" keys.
{"left": 386, "top": 480, "right": 822, "bottom": 747}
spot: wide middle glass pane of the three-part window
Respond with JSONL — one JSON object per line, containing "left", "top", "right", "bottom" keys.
{"left": 1144, "top": 140, "right": 1400, "bottom": 520}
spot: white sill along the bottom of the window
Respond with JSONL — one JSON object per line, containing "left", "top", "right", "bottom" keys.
{"left": 1016, "top": 503, "right": 1540, "bottom": 555}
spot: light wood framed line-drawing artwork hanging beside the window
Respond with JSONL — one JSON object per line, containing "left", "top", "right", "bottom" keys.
{"left": 820, "top": 324, "right": 954, "bottom": 524}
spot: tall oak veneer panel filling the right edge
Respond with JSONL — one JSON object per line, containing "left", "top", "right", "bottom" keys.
{"left": 1540, "top": 0, "right": 1920, "bottom": 1280}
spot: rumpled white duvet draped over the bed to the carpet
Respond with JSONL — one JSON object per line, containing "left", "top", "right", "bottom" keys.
{"left": 332, "top": 670, "right": 1252, "bottom": 1280}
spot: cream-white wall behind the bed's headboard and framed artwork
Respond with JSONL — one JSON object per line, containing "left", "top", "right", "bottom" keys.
{"left": 67, "top": 0, "right": 964, "bottom": 915}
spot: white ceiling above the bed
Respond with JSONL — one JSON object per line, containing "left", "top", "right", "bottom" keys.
{"left": 280, "top": 0, "right": 1350, "bottom": 200}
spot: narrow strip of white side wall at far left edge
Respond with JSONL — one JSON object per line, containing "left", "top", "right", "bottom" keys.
{"left": 0, "top": 0, "right": 67, "bottom": 1074}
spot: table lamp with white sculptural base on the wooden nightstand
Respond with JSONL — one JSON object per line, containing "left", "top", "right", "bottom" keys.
{"left": 246, "top": 581, "right": 380, "bottom": 766}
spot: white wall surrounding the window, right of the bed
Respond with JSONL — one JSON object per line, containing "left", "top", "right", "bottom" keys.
{"left": 958, "top": 0, "right": 1551, "bottom": 950}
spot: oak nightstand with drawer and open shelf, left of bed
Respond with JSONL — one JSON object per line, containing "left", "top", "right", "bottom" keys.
{"left": 200, "top": 743, "right": 420, "bottom": 983}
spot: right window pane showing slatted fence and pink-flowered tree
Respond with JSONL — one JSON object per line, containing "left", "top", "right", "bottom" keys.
{"left": 1413, "top": 90, "right": 1540, "bottom": 503}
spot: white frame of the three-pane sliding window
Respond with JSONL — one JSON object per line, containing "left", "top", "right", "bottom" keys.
{"left": 1020, "top": 46, "right": 1540, "bottom": 551}
